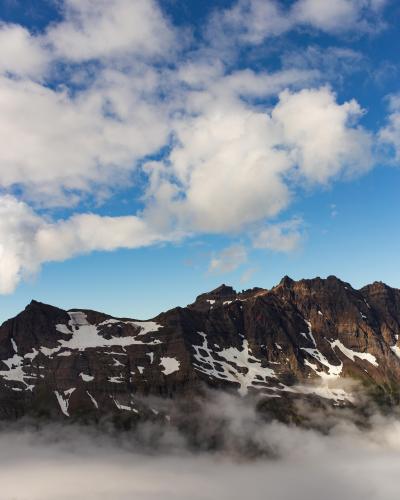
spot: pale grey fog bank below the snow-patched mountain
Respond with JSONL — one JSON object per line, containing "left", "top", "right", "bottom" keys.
{"left": 0, "top": 399, "right": 400, "bottom": 500}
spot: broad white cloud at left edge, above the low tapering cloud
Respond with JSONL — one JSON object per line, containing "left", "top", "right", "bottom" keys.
{"left": 0, "top": 67, "right": 168, "bottom": 205}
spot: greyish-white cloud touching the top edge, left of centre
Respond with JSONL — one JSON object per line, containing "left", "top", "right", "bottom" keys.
{"left": 46, "top": 0, "right": 174, "bottom": 62}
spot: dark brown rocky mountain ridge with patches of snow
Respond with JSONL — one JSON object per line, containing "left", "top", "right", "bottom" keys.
{"left": 0, "top": 276, "right": 400, "bottom": 419}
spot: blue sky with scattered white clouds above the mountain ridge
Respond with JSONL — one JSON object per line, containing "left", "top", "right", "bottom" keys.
{"left": 0, "top": 0, "right": 400, "bottom": 320}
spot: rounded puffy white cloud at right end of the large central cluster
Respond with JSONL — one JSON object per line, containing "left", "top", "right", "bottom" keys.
{"left": 272, "top": 87, "right": 372, "bottom": 183}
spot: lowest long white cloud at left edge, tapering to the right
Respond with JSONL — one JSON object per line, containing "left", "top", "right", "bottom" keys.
{"left": 0, "top": 195, "right": 168, "bottom": 293}
